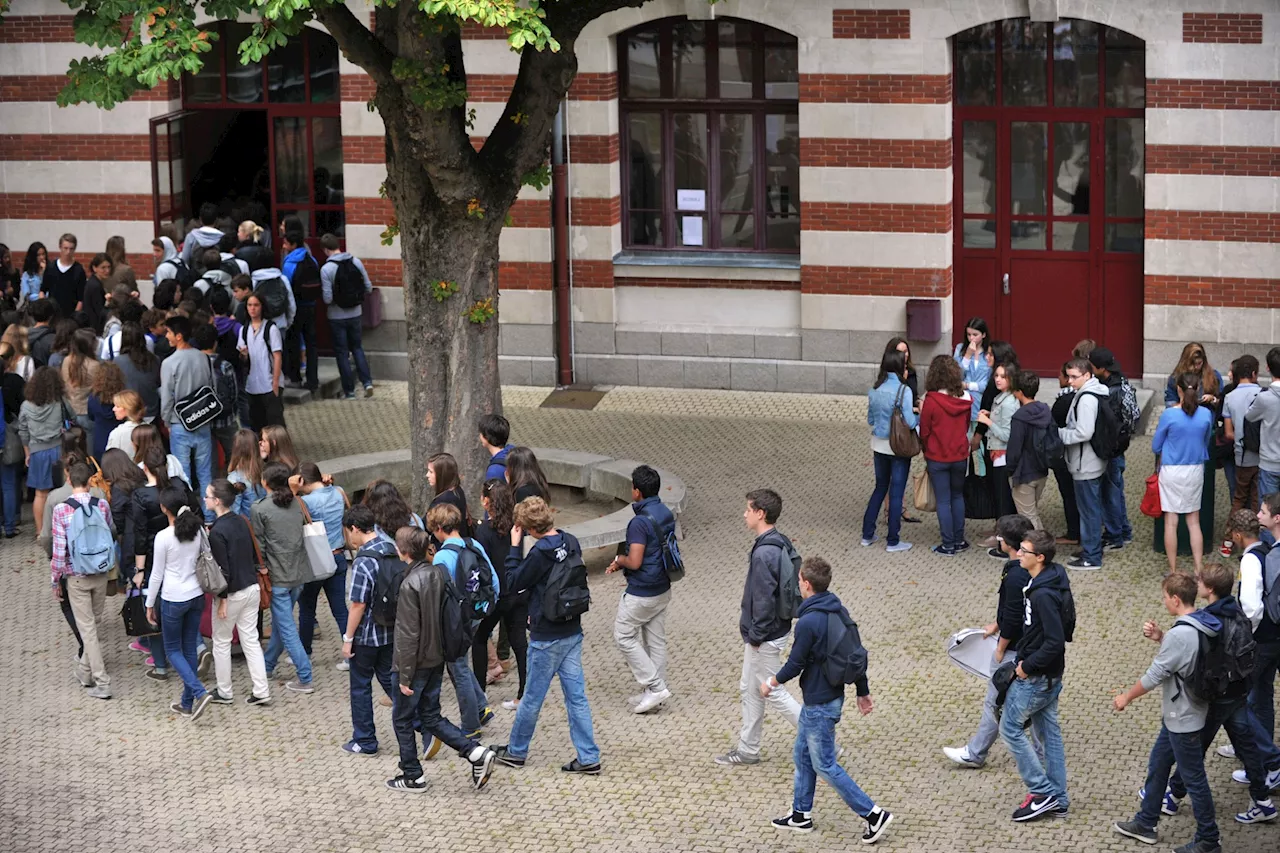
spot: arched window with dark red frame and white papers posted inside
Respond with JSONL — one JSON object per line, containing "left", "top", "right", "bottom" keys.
{"left": 618, "top": 18, "right": 800, "bottom": 252}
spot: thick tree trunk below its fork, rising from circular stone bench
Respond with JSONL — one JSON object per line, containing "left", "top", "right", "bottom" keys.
{"left": 387, "top": 141, "right": 507, "bottom": 511}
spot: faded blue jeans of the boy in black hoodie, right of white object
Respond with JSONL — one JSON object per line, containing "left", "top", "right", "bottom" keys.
{"left": 1000, "top": 675, "right": 1070, "bottom": 807}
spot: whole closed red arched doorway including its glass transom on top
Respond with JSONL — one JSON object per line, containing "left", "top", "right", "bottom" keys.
{"left": 952, "top": 18, "right": 1146, "bottom": 375}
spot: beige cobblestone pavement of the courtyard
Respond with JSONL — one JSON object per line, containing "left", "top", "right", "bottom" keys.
{"left": 0, "top": 383, "right": 1280, "bottom": 853}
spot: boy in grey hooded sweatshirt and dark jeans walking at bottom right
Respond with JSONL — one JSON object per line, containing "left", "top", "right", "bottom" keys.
{"left": 1111, "top": 573, "right": 1222, "bottom": 853}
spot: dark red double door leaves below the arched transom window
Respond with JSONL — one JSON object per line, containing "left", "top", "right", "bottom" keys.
{"left": 952, "top": 112, "right": 1143, "bottom": 375}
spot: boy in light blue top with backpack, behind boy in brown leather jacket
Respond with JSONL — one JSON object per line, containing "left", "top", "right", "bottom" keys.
{"left": 426, "top": 503, "right": 499, "bottom": 736}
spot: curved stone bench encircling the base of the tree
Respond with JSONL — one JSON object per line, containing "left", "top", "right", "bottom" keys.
{"left": 320, "top": 447, "right": 689, "bottom": 551}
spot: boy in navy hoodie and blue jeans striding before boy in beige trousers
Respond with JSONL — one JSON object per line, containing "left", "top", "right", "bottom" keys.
{"left": 759, "top": 557, "right": 893, "bottom": 844}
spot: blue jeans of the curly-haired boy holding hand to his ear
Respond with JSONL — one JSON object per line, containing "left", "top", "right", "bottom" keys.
{"left": 507, "top": 634, "right": 600, "bottom": 765}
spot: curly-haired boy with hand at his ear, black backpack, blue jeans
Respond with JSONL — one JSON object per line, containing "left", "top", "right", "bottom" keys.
{"left": 497, "top": 497, "right": 600, "bottom": 776}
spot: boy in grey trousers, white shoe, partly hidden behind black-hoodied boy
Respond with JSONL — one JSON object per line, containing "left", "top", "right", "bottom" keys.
{"left": 942, "top": 512, "right": 1043, "bottom": 770}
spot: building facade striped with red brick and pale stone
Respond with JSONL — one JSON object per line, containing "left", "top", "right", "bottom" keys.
{"left": 0, "top": 0, "right": 1280, "bottom": 392}
